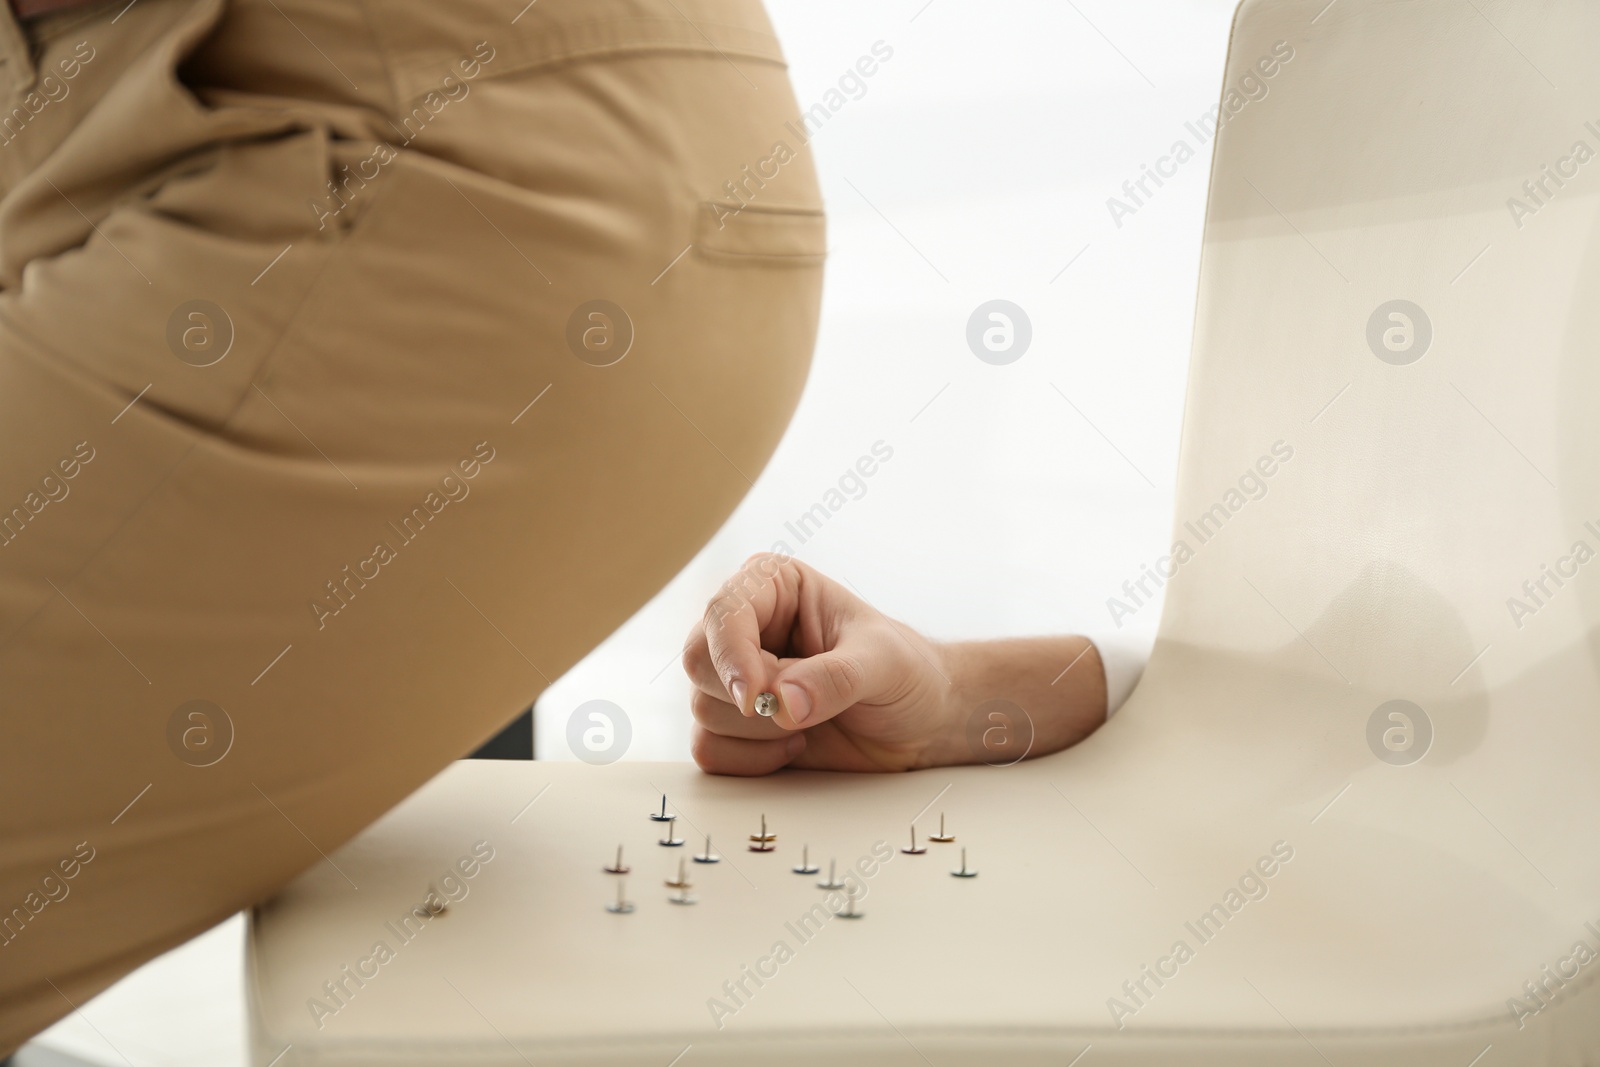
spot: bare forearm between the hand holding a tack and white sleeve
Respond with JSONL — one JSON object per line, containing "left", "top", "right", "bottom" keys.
{"left": 939, "top": 637, "right": 1106, "bottom": 763}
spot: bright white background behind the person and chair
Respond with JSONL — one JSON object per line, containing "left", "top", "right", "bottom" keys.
{"left": 45, "top": 0, "right": 1234, "bottom": 1067}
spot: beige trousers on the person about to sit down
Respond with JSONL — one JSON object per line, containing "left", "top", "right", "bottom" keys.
{"left": 0, "top": 0, "right": 824, "bottom": 1056}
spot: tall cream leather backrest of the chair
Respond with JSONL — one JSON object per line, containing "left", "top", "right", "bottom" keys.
{"left": 1118, "top": 0, "right": 1600, "bottom": 792}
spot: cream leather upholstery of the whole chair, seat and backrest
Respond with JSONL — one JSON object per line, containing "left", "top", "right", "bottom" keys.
{"left": 250, "top": 0, "right": 1600, "bottom": 1067}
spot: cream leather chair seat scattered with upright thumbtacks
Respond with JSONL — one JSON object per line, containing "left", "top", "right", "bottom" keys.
{"left": 250, "top": 649, "right": 1600, "bottom": 1067}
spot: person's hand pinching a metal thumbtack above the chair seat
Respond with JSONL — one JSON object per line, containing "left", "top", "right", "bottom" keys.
{"left": 683, "top": 555, "right": 970, "bottom": 774}
